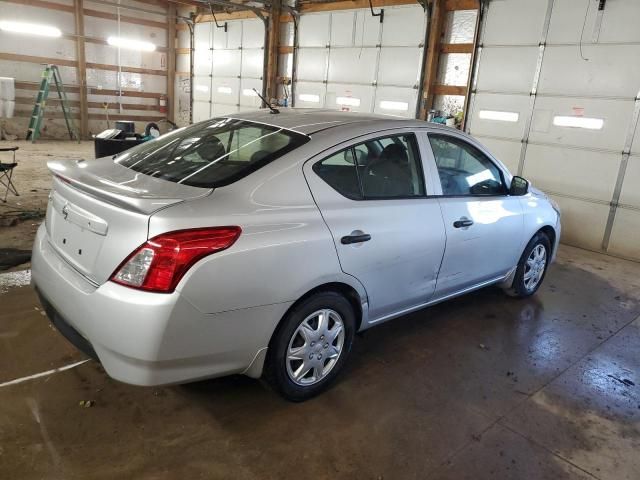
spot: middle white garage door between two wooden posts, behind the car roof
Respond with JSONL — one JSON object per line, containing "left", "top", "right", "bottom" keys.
{"left": 295, "top": 5, "right": 426, "bottom": 118}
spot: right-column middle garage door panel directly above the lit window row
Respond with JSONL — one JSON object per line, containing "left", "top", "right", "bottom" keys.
{"left": 378, "top": 47, "right": 422, "bottom": 87}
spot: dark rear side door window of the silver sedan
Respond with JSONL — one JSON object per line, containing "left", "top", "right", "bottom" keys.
{"left": 313, "top": 134, "right": 425, "bottom": 200}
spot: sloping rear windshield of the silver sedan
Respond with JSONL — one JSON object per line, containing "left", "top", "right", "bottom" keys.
{"left": 115, "top": 118, "right": 309, "bottom": 188}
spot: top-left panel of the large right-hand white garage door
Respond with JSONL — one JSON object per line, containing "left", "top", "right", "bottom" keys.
{"left": 482, "top": 0, "right": 547, "bottom": 45}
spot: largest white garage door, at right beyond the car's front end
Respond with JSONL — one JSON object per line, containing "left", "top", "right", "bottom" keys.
{"left": 468, "top": 0, "right": 640, "bottom": 259}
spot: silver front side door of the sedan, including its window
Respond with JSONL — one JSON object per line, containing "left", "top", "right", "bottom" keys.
{"left": 425, "top": 133, "right": 524, "bottom": 297}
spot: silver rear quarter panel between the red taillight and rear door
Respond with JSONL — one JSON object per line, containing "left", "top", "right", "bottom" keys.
{"left": 149, "top": 150, "right": 366, "bottom": 320}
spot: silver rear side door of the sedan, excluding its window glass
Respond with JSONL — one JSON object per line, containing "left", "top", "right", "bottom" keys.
{"left": 304, "top": 132, "right": 445, "bottom": 322}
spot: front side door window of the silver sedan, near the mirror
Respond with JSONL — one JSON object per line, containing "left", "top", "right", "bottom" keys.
{"left": 429, "top": 134, "right": 507, "bottom": 196}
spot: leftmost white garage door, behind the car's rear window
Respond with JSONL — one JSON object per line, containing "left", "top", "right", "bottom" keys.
{"left": 193, "top": 19, "right": 264, "bottom": 122}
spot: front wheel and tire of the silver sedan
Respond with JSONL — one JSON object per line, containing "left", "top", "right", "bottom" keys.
{"left": 505, "top": 232, "right": 551, "bottom": 298}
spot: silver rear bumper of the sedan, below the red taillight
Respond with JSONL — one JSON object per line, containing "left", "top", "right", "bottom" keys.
{"left": 32, "top": 226, "right": 290, "bottom": 385}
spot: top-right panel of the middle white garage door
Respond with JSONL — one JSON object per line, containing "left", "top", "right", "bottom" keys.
{"left": 382, "top": 5, "right": 425, "bottom": 47}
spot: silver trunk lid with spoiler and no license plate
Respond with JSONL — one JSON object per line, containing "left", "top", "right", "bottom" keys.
{"left": 45, "top": 158, "right": 211, "bottom": 285}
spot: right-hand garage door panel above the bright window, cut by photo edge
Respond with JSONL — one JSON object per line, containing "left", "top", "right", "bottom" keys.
{"left": 538, "top": 45, "right": 640, "bottom": 97}
